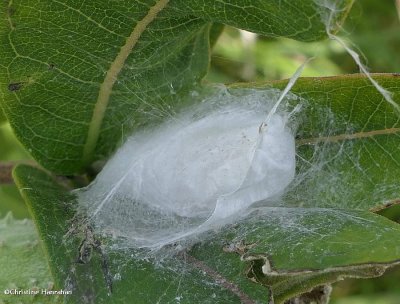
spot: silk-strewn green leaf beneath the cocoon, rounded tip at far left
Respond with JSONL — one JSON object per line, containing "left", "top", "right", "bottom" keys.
{"left": 11, "top": 165, "right": 267, "bottom": 304}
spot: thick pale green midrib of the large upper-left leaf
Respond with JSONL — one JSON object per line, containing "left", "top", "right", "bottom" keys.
{"left": 82, "top": 0, "right": 169, "bottom": 166}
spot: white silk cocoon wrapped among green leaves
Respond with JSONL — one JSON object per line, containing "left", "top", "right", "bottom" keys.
{"left": 78, "top": 90, "right": 295, "bottom": 248}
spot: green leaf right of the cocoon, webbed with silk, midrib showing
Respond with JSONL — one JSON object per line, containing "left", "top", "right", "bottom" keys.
{"left": 232, "top": 74, "right": 400, "bottom": 210}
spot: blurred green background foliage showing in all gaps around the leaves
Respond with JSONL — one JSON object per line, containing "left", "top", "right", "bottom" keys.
{"left": 0, "top": 0, "right": 400, "bottom": 304}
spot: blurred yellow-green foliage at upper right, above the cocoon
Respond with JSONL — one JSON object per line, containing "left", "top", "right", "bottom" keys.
{"left": 207, "top": 0, "right": 400, "bottom": 83}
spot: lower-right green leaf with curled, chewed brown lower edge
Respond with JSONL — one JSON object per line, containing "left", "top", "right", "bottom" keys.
{"left": 192, "top": 208, "right": 400, "bottom": 303}
